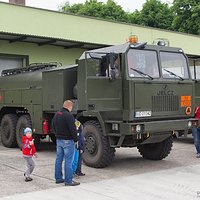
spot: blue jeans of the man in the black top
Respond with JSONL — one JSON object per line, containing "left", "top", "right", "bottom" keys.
{"left": 55, "top": 139, "right": 75, "bottom": 183}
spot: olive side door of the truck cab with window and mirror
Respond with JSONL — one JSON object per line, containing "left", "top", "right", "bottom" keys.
{"left": 86, "top": 54, "right": 122, "bottom": 111}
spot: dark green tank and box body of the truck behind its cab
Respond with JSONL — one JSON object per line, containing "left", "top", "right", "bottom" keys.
{"left": 0, "top": 63, "right": 77, "bottom": 112}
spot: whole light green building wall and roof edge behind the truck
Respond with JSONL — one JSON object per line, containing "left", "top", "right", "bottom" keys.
{"left": 0, "top": 2, "right": 200, "bottom": 72}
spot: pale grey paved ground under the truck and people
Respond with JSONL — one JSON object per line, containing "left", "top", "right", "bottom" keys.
{"left": 0, "top": 138, "right": 200, "bottom": 200}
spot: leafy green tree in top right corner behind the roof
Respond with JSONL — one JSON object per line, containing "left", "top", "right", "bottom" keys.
{"left": 172, "top": 0, "right": 200, "bottom": 35}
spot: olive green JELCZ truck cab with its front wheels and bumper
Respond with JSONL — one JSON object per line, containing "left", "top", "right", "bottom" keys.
{"left": 78, "top": 37, "right": 198, "bottom": 167}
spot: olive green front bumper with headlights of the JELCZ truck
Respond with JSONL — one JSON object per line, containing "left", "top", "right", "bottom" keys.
{"left": 109, "top": 119, "right": 198, "bottom": 147}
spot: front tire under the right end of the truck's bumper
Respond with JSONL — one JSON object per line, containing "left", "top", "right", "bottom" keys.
{"left": 137, "top": 137, "right": 173, "bottom": 160}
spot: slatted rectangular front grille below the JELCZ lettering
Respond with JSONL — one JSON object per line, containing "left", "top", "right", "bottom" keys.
{"left": 151, "top": 96, "right": 179, "bottom": 112}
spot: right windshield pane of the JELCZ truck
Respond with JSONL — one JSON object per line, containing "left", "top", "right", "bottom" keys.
{"left": 160, "top": 52, "right": 189, "bottom": 80}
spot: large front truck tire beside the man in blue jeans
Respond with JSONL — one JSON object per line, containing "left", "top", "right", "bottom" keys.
{"left": 83, "top": 120, "right": 115, "bottom": 168}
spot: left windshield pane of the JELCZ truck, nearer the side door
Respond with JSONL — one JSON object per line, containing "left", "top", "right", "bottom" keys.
{"left": 127, "top": 49, "right": 159, "bottom": 78}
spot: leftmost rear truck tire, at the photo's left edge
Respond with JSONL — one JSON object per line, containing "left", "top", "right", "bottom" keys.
{"left": 1, "top": 114, "right": 18, "bottom": 148}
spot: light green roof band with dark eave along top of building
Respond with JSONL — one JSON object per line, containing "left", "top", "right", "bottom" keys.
{"left": 0, "top": 2, "right": 200, "bottom": 55}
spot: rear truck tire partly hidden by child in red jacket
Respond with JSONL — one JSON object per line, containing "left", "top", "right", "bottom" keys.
{"left": 16, "top": 115, "right": 32, "bottom": 149}
